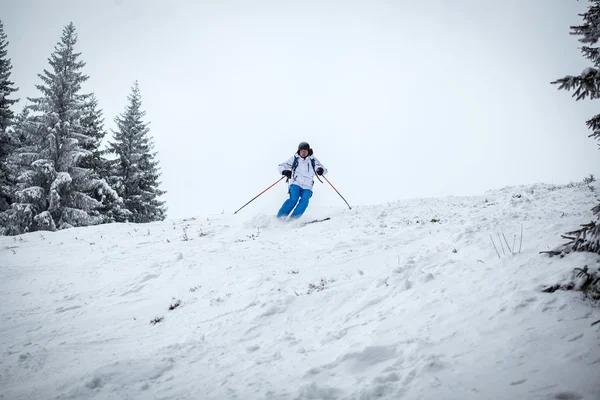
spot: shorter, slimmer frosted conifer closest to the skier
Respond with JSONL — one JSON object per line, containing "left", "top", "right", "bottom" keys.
{"left": 109, "top": 81, "right": 166, "bottom": 223}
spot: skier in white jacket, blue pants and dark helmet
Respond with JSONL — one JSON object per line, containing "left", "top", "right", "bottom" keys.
{"left": 277, "top": 142, "right": 327, "bottom": 219}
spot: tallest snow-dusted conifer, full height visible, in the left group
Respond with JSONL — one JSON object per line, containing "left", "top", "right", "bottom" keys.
{"left": 8, "top": 23, "right": 103, "bottom": 234}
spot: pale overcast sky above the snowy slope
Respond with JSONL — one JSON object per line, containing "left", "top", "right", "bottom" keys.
{"left": 0, "top": 0, "right": 600, "bottom": 218}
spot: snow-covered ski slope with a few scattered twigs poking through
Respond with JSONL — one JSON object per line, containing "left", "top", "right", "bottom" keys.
{"left": 0, "top": 184, "right": 600, "bottom": 400}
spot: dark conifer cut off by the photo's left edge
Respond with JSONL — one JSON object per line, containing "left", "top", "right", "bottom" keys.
{"left": 0, "top": 21, "right": 19, "bottom": 212}
